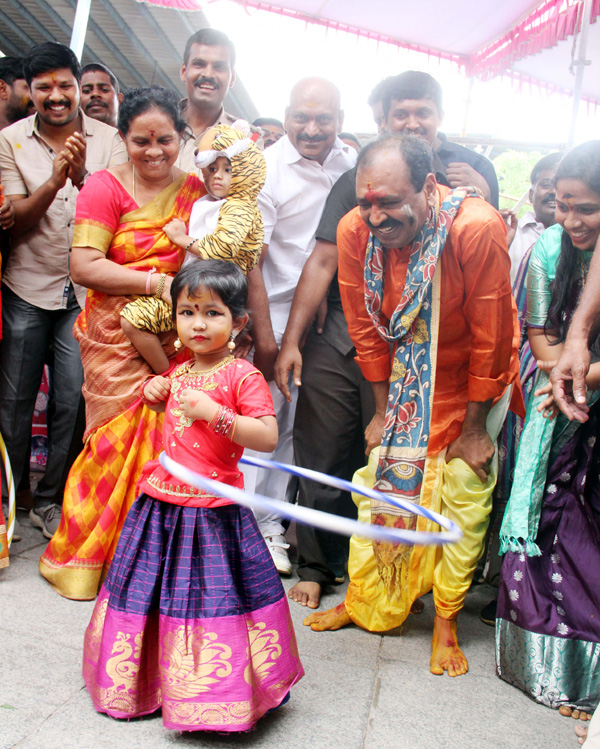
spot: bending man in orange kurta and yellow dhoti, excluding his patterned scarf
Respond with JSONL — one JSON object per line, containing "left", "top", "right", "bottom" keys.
{"left": 305, "top": 136, "right": 522, "bottom": 676}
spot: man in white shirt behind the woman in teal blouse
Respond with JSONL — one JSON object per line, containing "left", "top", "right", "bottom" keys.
{"left": 503, "top": 153, "right": 561, "bottom": 286}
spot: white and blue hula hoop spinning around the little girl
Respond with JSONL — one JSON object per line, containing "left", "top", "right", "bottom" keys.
{"left": 160, "top": 452, "right": 463, "bottom": 546}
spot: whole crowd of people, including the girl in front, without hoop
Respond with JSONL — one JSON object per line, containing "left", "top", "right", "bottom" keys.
{"left": 0, "top": 29, "right": 600, "bottom": 747}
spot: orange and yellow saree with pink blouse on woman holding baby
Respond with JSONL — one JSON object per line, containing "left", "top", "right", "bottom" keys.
{"left": 40, "top": 172, "right": 203, "bottom": 600}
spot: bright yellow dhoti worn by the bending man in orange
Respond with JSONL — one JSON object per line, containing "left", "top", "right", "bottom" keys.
{"left": 345, "top": 450, "right": 496, "bottom": 632}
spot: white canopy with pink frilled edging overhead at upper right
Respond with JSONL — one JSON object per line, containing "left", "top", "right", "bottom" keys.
{"left": 110, "top": 0, "right": 600, "bottom": 142}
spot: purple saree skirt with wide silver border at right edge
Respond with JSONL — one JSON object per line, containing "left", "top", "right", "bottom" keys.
{"left": 496, "top": 404, "right": 600, "bottom": 712}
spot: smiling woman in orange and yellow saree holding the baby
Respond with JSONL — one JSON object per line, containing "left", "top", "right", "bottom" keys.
{"left": 40, "top": 87, "right": 205, "bottom": 600}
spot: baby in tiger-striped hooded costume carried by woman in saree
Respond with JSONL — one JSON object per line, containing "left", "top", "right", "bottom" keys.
{"left": 121, "top": 120, "right": 267, "bottom": 374}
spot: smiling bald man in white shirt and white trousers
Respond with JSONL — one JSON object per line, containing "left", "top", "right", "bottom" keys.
{"left": 244, "top": 78, "right": 356, "bottom": 574}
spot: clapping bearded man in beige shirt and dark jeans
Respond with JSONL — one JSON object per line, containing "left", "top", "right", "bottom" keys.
{"left": 0, "top": 42, "right": 127, "bottom": 538}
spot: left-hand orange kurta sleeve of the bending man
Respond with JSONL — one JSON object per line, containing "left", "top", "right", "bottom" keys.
{"left": 337, "top": 208, "right": 391, "bottom": 382}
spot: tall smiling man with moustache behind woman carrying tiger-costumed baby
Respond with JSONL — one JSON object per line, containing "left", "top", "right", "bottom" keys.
{"left": 176, "top": 28, "right": 237, "bottom": 172}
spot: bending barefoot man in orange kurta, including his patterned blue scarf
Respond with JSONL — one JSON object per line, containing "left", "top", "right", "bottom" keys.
{"left": 304, "top": 136, "right": 522, "bottom": 676}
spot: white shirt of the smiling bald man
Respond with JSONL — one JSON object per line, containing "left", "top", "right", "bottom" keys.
{"left": 258, "top": 135, "right": 357, "bottom": 336}
